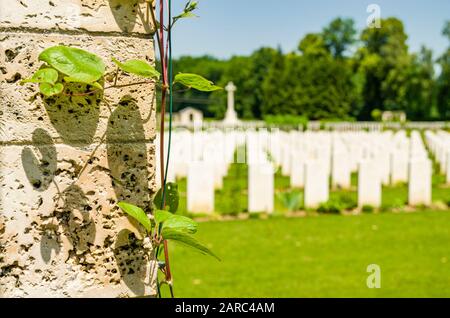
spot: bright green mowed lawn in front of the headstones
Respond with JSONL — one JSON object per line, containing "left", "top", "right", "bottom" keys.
{"left": 165, "top": 212, "right": 450, "bottom": 297}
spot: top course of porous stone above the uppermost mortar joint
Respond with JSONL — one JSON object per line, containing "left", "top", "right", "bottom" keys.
{"left": 0, "top": 0, "right": 151, "bottom": 35}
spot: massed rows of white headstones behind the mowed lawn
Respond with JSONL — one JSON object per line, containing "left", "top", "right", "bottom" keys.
{"left": 156, "top": 130, "right": 440, "bottom": 213}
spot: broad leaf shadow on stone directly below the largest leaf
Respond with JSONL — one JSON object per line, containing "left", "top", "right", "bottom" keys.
{"left": 44, "top": 83, "right": 103, "bottom": 146}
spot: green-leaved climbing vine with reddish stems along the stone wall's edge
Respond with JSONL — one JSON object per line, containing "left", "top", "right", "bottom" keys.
{"left": 21, "top": 0, "right": 221, "bottom": 297}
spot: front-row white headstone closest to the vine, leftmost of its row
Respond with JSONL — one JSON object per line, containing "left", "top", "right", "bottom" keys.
{"left": 187, "top": 162, "right": 214, "bottom": 213}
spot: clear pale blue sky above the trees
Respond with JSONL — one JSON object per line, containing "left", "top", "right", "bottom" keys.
{"left": 172, "top": 0, "right": 450, "bottom": 58}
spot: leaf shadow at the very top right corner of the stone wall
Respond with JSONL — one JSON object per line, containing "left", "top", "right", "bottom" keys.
{"left": 109, "top": 0, "right": 151, "bottom": 33}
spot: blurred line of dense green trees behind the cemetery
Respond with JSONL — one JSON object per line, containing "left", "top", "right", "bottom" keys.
{"left": 174, "top": 18, "right": 450, "bottom": 120}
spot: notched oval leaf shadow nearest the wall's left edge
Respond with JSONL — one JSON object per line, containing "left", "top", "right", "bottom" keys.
{"left": 21, "top": 128, "right": 57, "bottom": 192}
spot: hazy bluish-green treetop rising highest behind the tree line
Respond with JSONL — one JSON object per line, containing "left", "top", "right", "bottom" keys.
{"left": 322, "top": 18, "right": 357, "bottom": 58}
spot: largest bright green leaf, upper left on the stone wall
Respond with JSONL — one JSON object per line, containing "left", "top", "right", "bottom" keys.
{"left": 39, "top": 45, "right": 105, "bottom": 84}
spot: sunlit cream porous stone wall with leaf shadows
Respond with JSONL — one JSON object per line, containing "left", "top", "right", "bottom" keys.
{"left": 0, "top": 0, "right": 156, "bottom": 297}
